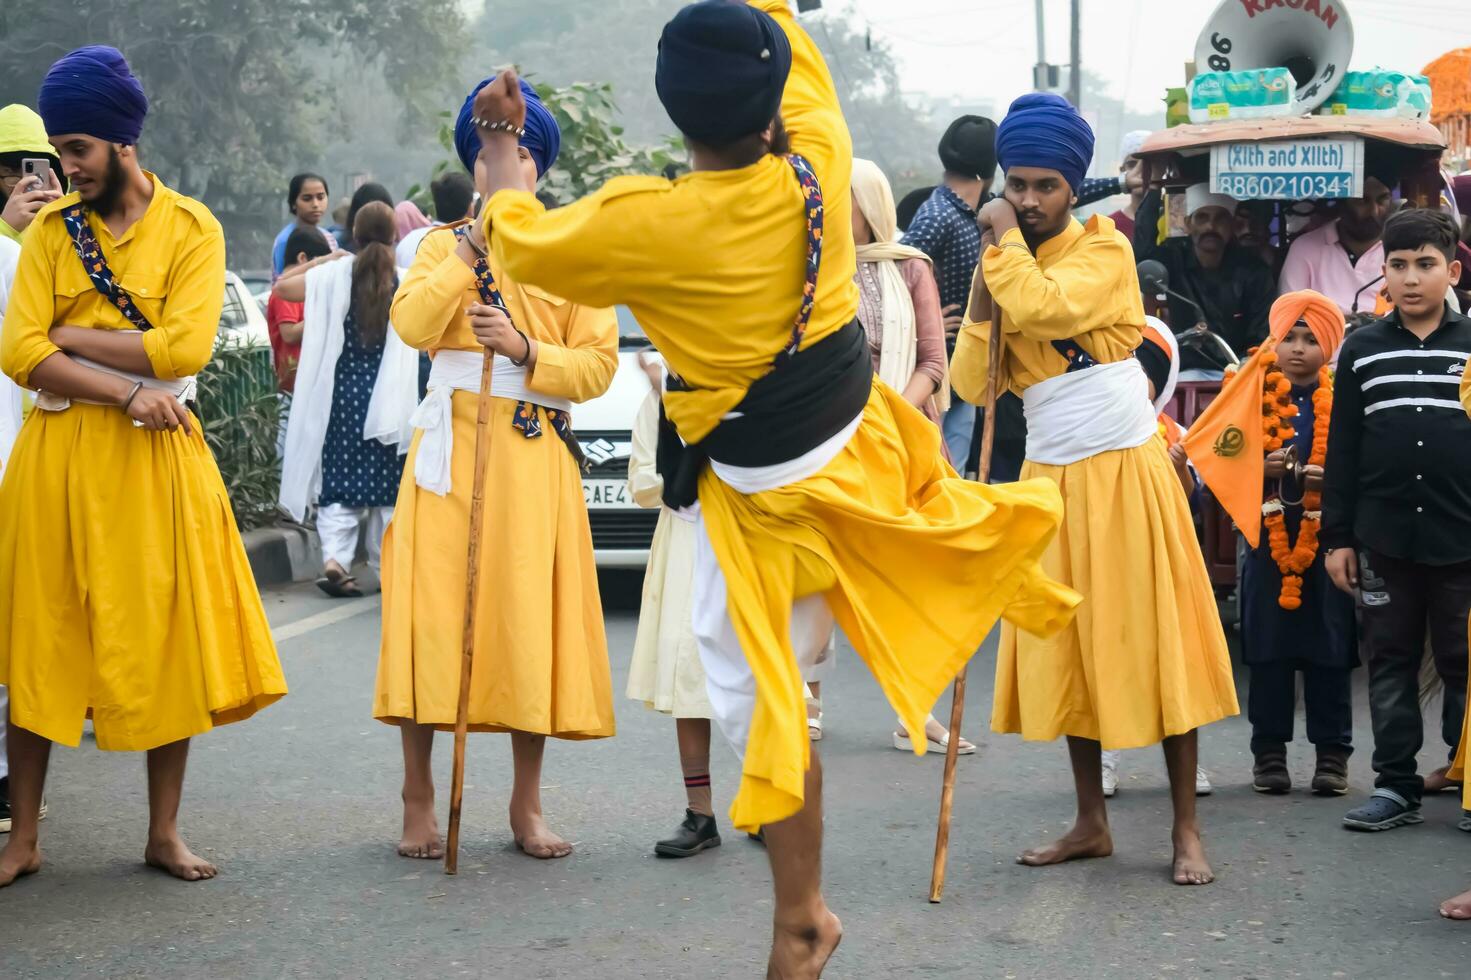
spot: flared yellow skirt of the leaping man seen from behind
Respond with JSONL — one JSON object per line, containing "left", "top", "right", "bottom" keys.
{"left": 700, "top": 380, "right": 1078, "bottom": 830}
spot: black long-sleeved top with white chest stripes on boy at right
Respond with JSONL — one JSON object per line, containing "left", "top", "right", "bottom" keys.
{"left": 1321, "top": 306, "right": 1471, "bottom": 565}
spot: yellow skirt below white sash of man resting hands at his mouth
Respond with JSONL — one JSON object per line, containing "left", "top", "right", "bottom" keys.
{"left": 991, "top": 437, "right": 1239, "bottom": 749}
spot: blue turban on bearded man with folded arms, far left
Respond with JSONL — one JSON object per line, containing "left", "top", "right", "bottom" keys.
{"left": 40, "top": 44, "right": 149, "bottom": 146}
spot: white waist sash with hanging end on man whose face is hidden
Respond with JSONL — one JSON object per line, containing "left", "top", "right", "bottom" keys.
{"left": 409, "top": 350, "right": 572, "bottom": 497}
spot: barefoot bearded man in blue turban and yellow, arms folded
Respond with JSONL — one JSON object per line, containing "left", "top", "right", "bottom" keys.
{"left": 0, "top": 47, "right": 285, "bottom": 886}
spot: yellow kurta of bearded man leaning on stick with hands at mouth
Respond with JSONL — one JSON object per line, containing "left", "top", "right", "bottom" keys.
{"left": 950, "top": 216, "right": 1237, "bottom": 749}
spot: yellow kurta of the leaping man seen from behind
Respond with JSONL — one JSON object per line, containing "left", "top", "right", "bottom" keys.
{"left": 487, "top": 0, "right": 1075, "bottom": 830}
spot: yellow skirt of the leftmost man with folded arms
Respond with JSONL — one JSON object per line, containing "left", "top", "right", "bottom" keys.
{"left": 0, "top": 405, "right": 285, "bottom": 752}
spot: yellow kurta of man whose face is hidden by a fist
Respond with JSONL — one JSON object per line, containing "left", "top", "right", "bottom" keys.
{"left": 374, "top": 219, "right": 618, "bottom": 739}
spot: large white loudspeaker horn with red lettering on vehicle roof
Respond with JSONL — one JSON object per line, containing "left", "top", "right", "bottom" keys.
{"left": 1196, "top": 0, "right": 1353, "bottom": 113}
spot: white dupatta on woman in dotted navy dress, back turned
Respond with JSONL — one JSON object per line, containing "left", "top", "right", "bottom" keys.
{"left": 279, "top": 256, "right": 419, "bottom": 521}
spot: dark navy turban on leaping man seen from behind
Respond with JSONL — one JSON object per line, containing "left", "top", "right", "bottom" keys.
{"left": 653, "top": 0, "right": 791, "bottom": 146}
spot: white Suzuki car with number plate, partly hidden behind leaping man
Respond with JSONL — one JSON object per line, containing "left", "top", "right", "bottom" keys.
{"left": 572, "top": 306, "right": 659, "bottom": 568}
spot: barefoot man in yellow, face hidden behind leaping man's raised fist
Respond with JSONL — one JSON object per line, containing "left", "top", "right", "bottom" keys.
{"left": 374, "top": 78, "right": 618, "bottom": 870}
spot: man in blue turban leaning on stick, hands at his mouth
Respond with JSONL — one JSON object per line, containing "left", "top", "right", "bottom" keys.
{"left": 952, "top": 94, "right": 1237, "bottom": 884}
